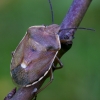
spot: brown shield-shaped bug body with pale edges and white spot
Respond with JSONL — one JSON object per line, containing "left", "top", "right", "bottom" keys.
{"left": 10, "top": 24, "right": 61, "bottom": 87}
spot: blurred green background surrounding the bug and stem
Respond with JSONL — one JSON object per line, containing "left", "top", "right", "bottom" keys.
{"left": 0, "top": 0, "right": 100, "bottom": 100}
